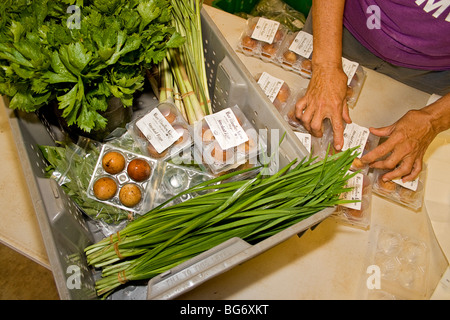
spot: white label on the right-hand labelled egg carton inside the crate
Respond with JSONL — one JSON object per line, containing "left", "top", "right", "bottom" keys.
{"left": 205, "top": 108, "right": 248, "bottom": 150}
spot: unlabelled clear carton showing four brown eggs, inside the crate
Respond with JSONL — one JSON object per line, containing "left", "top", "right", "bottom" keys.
{"left": 87, "top": 144, "right": 157, "bottom": 214}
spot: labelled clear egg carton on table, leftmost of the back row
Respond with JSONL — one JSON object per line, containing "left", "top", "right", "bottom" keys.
{"left": 237, "top": 17, "right": 288, "bottom": 63}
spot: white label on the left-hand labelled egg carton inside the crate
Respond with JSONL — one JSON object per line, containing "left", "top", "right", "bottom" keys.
{"left": 136, "top": 108, "right": 182, "bottom": 153}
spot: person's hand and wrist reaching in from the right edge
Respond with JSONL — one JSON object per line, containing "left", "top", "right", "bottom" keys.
{"left": 361, "top": 94, "right": 450, "bottom": 181}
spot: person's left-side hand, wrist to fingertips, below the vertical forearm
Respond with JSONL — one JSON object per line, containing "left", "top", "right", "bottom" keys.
{"left": 295, "top": 65, "right": 352, "bottom": 151}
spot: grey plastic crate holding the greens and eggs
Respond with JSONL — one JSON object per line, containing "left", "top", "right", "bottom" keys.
{"left": 5, "top": 10, "right": 334, "bottom": 300}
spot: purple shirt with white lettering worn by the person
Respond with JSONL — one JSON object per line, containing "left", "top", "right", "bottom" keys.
{"left": 344, "top": 0, "right": 450, "bottom": 70}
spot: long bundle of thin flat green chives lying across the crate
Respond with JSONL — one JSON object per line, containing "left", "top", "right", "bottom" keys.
{"left": 85, "top": 149, "right": 356, "bottom": 297}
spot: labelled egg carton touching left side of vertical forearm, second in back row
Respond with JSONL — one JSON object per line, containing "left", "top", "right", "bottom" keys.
{"left": 276, "top": 31, "right": 313, "bottom": 78}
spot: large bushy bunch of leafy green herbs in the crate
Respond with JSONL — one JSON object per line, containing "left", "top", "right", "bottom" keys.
{"left": 0, "top": 0, "right": 185, "bottom": 132}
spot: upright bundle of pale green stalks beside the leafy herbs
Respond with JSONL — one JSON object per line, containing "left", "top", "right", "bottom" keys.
{"left": 159, "top": 0, "right": 212, "bottom": 124}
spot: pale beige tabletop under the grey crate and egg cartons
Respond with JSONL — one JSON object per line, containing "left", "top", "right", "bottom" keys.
{"left": 0, "top": 5, "right": 450, "bottom": 299}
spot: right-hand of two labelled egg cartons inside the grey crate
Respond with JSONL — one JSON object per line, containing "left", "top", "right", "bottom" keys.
{"left": 194, "top": 105, "right": 266, "bottom": 174}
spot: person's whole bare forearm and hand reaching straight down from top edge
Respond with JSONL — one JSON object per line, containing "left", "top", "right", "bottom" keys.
{"left": 296, "top": 0, "right": 351, "bottom": 150}
